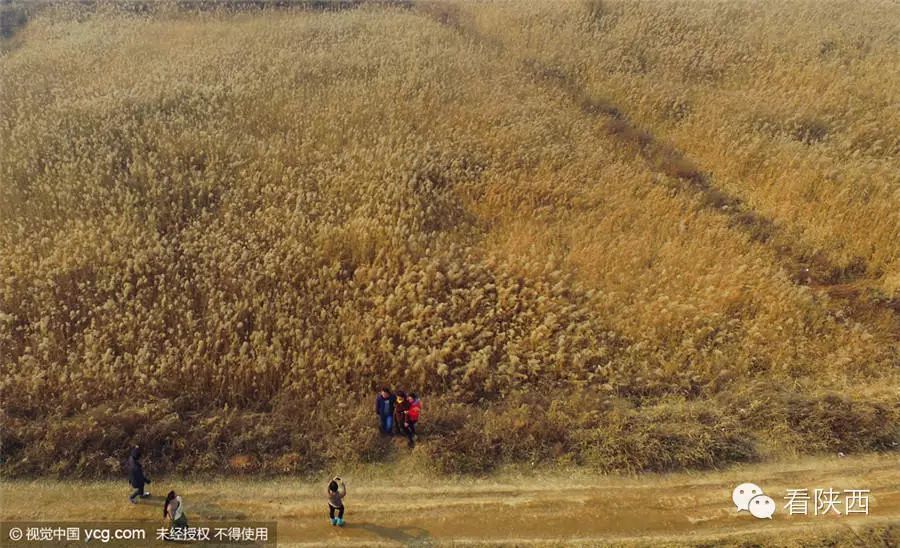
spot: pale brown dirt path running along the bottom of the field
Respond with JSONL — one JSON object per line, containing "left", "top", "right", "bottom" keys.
{"left": 0, "top": 454, "right": 900, "bottom": 546}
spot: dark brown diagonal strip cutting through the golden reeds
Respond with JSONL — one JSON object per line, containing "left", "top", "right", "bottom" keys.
{"left": 414, "top": 1, "right": 900, "bottom": 343}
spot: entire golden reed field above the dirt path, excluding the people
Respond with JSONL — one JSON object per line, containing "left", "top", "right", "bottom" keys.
{"left": 0, "top": 0, "right": 900, "bottom": 477}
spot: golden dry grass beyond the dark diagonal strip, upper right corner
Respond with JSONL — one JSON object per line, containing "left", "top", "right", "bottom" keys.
{"left": 460, "top": 0, "right": 900, "bottom": 296}
